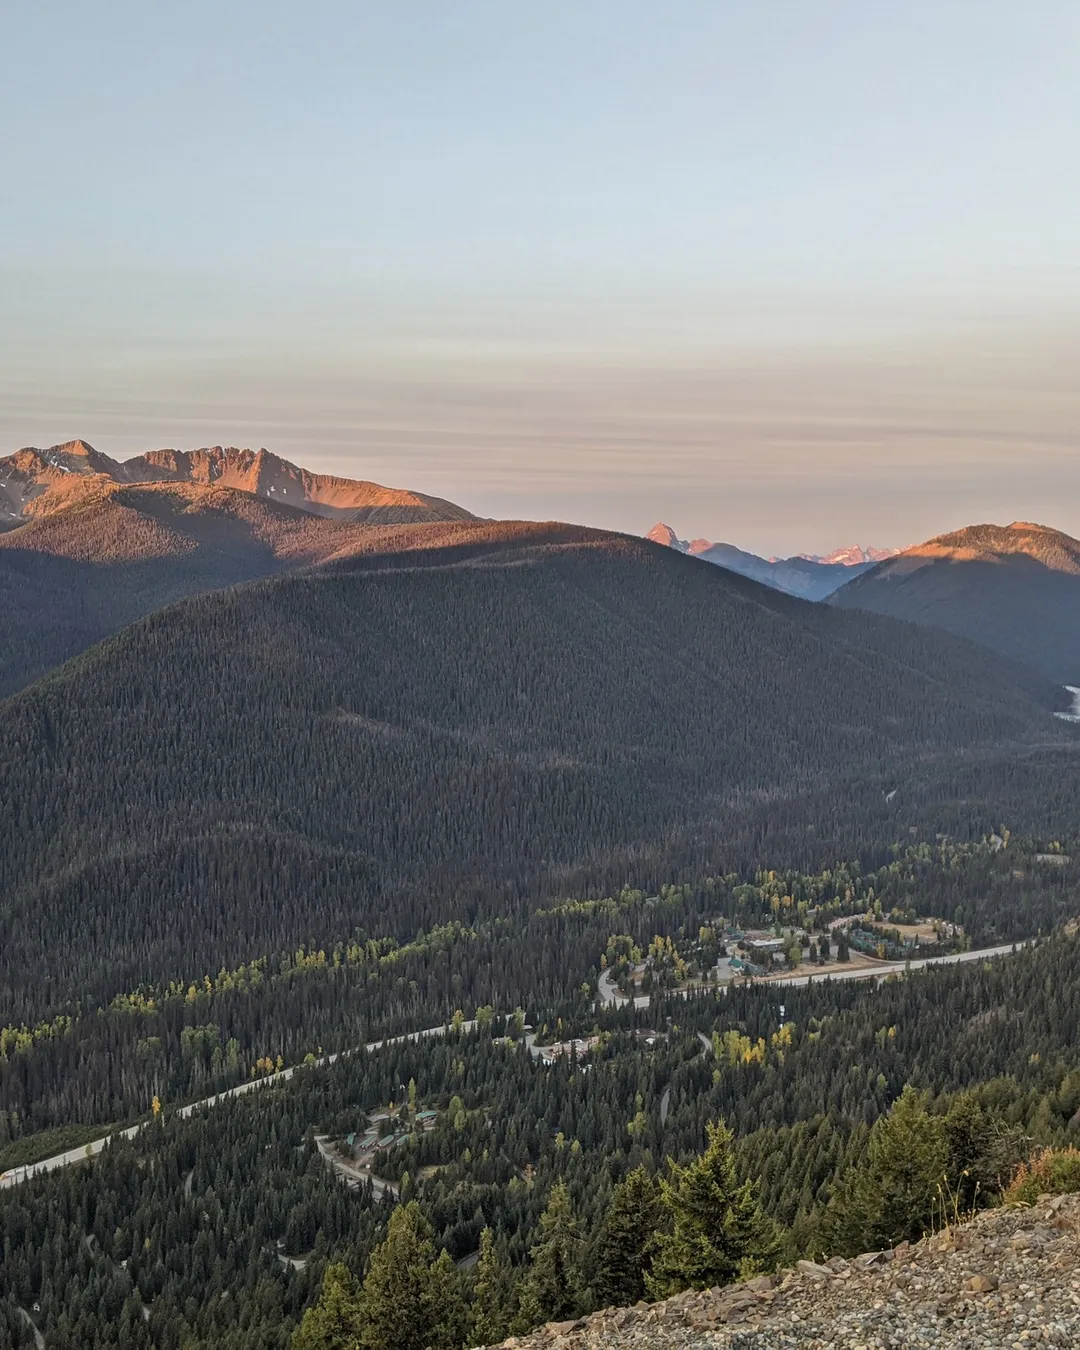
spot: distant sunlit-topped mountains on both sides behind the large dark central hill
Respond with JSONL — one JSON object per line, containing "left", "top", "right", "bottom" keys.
{"left": 8, "top": 440, "right": 1080, "bottom": 697}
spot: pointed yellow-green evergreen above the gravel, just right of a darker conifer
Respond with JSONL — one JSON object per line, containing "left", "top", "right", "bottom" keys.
{"left": 645, "top": 1119, "right": 779, "bottom": 1299}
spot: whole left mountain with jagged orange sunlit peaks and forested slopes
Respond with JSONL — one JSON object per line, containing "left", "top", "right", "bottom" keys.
{"left": 0, "top": 440, "right": 475, "bottom": 698}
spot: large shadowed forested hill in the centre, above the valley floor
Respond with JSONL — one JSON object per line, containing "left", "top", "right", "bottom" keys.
{"left": 0, "top": 525, "right": 1072, "bottom": 1015}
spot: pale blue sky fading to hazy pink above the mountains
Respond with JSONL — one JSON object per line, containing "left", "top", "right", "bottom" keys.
{"left": 0, "top": 0, "right": 1080, "bottom": 554}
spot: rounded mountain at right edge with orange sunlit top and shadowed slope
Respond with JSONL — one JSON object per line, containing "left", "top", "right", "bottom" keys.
{"left": 829, "top": 521, "right": 1080, "bottom": 684}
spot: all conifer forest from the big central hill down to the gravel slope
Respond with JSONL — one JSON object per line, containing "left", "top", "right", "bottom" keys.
{"left": 0, "top": 527, "right": 1080, "bottom": 1350}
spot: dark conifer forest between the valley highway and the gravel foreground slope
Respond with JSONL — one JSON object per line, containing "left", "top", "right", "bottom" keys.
{"left": 0, "top": 934, "right": 1080, "bottom": 1347}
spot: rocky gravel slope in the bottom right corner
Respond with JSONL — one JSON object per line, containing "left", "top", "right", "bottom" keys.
{"left": 486, "top": 1196, "right": 1080, "bottom": 1350}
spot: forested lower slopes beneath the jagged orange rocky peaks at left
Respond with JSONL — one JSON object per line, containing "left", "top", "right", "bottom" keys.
{"left": 0, "top": 483, "right": 486, "bottom": 697}
